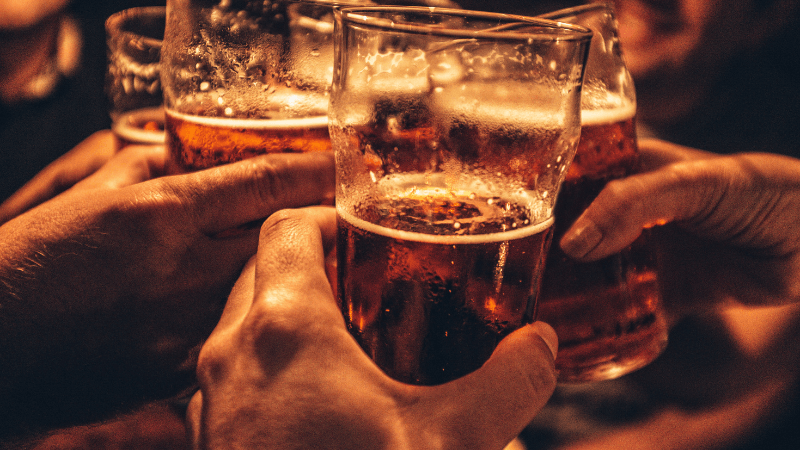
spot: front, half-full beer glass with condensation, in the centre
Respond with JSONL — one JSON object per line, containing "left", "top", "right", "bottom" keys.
{"left": 329, "top": 7, "right": 591, "bottom": 385}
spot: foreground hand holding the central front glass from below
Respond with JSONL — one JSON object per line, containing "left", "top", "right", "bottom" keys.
{"left": 187, "top": 207, "right": 557, "bottom": 450}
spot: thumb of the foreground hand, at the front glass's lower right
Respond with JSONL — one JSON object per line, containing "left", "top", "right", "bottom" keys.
{"left": 423, "top": 322, "right": 558, "bottom": 449}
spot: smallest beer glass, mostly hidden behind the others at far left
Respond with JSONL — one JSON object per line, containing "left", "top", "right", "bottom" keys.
{"left": 105, "top": 6, "right": 166, "bottom": 149}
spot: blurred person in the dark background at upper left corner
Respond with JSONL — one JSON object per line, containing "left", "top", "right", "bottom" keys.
{"left": 0, "top": 0, "right": 165, "bottom": 202}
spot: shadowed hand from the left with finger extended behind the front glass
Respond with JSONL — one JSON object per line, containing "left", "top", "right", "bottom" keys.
{"left": 0, "top": 146, "right": 334, "bottom": 436}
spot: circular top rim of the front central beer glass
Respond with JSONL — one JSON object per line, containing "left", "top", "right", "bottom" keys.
{"left": 334, "top": 6, "right": 593, "bottom": 41}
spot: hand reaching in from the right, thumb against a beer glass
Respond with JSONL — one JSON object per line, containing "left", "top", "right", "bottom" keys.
{"left": 561, "top": 140, "right": 800, "bottom": 314}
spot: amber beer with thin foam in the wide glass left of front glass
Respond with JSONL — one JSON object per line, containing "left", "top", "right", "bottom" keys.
{"left": 166, "top": 110, "right": 331, "bottom": 171}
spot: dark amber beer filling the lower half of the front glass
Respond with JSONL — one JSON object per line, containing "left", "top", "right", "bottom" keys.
{"left": 337, "top": 188, "right": 553, "bottom": 385}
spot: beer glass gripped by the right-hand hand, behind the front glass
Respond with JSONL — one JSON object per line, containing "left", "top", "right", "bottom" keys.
{"left": 539, "top": 3, "right": 668, "bottom": 382}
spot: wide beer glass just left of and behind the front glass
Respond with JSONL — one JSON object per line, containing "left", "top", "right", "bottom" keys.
{"left": 162, "top": 0, "right": 374, "bottom": 172}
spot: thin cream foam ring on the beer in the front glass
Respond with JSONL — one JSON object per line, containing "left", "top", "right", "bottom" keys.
{"left": 336, "top": 206, "right": 554, "bottom": 245}
